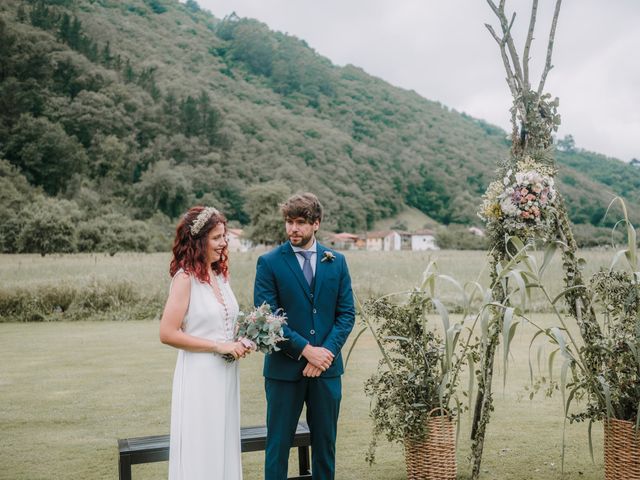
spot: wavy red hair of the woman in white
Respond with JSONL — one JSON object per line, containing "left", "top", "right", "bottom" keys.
{"left": 169, "top": 206, "right": 229, "bottom": 283}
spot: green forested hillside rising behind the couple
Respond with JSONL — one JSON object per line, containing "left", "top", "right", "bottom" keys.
{"left": 0, "top": 0, "right": 640, "bottom": 255}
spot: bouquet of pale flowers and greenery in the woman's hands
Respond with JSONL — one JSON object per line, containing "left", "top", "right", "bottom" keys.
{"left": 225, "top": 303, "right": 287, "bottom": 361}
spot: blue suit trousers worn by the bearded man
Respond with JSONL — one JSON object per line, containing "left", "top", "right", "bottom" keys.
{"left": 265, "top": 377, "right": 342, "bottom": 480}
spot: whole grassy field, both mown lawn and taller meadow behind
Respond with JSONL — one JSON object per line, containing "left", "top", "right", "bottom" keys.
{"left": 0, "top": 251, "right": 613, "bottom": 480}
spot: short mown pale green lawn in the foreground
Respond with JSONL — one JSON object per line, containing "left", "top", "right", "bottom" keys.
{"left": 0, "top": 316, "right": 603, "bottom": 480}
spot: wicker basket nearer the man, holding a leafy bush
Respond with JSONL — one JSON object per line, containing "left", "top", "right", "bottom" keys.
{"left": 404, "top": 408, "right": 456, "bottom": 480}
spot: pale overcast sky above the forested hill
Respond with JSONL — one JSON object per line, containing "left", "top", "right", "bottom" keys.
{"left": 198, "top": 0, "right": 640, "bottom": 161}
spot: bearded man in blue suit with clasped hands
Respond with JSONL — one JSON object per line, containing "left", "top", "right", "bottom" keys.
{"left": 253, "top": 193, "right": 355, "bottom": 480}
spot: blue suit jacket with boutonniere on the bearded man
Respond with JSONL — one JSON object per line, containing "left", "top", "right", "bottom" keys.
{"left": 253, "top": 242, "right": 355, "bottom": 381}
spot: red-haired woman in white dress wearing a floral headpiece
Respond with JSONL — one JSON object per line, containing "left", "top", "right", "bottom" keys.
{"left": 160, "top": 207, "right": 250, "bottom": 480}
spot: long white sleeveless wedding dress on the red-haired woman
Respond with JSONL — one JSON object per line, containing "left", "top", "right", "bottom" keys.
{"left": 169, "top": 271, "right": 242, "bottom": 480}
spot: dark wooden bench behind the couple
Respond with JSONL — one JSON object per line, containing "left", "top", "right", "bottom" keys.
{"left": 118, "top": 422, "right": 311, "bottom": 480}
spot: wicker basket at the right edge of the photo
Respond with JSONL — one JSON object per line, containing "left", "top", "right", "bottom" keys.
{"left": 604, "top": 418, "right": 640, "bottom": 480}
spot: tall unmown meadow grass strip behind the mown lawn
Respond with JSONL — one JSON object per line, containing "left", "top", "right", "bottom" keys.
{"left": 0, "top": 246, "right": 615, "bottom": 322}
